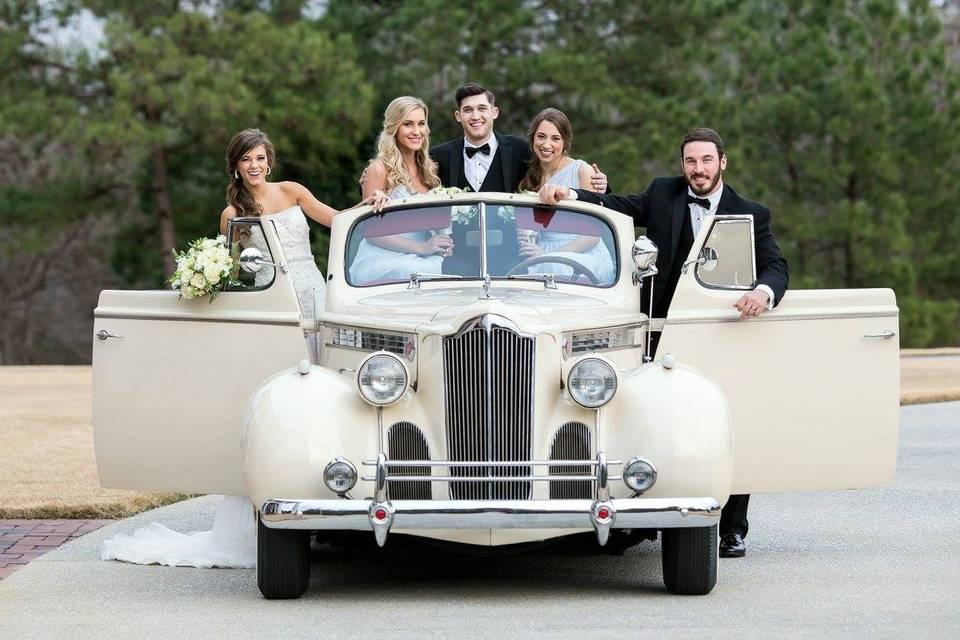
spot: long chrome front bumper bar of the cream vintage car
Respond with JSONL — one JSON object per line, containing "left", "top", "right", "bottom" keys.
{"left": 260, "top": 497, "right": 720, "bottom": 531}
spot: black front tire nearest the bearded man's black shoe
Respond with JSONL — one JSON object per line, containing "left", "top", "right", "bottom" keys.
{"left": 661, "top": 525, "right": 717, "bottom": 596}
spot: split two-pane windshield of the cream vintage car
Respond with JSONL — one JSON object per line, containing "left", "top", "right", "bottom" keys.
{"left": 346, "top": 202, "right": 618, "bottom": 287}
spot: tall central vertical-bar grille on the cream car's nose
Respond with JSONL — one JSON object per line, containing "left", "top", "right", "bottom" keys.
{"left": 443, "top": 315, "right": 535, "bottom": 500}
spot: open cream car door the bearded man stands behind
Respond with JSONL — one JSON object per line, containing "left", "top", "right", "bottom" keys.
{"left": 657, "top": 216, "right": 900, "bottom": 494}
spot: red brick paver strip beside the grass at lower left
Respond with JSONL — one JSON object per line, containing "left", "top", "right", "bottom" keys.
{"left": 0, "top": 520, "right": 113, "bottom": 580}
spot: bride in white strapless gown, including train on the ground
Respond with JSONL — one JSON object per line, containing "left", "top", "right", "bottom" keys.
{"left": 101, "top": 129, "right": 389, "bottom": 568}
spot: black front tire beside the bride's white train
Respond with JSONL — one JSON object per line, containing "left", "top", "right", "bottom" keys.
{"left": 257, "top": 516, "right": 310, "bottom": 600}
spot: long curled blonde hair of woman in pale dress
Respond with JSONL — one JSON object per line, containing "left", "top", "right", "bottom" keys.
{"left": 361, "top": 96, "right": 440, "bottom": 193}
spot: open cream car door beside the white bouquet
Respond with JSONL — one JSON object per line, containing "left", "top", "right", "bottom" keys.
{"left": 93, "top": 218, "right": 309, "bottom": 495}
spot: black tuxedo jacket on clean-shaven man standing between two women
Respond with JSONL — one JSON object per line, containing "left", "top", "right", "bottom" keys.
{"left": 430, "top": 132, "right": 530, "bottom": 193}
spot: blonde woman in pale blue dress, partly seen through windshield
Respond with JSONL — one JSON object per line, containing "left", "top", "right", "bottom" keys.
{"left": 350, "top": 96, "right": 453, "bottom": 284}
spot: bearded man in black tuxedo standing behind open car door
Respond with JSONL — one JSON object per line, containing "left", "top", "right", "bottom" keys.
{"left": 540, "top": 128, "right": 788, "bottom": 558}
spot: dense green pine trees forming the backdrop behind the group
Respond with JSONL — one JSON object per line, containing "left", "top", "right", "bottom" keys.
{"left": 0, "top": 0, "right": 960, "bottom": 364}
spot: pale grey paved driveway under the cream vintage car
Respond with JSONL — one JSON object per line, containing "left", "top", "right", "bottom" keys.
{"left": 0, "top": 402, "right": 960, "bottom": 640}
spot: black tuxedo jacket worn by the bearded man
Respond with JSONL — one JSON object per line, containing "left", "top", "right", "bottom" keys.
{"left": 577, "top": 176, "right": 789, "bottom": 318}
